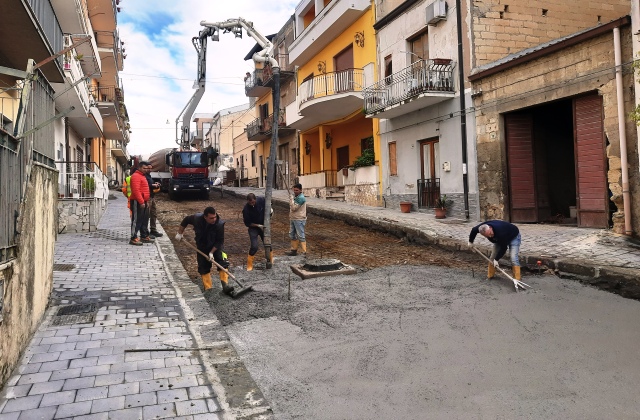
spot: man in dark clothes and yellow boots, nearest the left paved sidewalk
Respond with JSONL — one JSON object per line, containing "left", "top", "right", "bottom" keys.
{"left": 176, "top": 207, "right": 233, "bottom": 296}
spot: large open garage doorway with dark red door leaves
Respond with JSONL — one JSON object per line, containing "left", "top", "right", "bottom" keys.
{"left": 504, "top": 94, "right": 610, "bottom": 228}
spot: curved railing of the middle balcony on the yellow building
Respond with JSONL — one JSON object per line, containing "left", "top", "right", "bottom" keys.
{"left": 299, "top": 69, "right": 364, "bottom": 104}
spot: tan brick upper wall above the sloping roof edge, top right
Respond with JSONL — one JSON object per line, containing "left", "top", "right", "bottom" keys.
{"left": 471, "top": 0, "right": 631, "bottom": 67}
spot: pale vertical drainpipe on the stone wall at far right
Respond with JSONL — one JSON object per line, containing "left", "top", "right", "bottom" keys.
{"left": 613, "top": 27, "right": 633, "bottom": 235}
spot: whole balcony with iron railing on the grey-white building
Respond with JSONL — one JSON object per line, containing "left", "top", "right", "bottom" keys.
{"left": 363, "top": 59, "right": 455, "bottom": 118}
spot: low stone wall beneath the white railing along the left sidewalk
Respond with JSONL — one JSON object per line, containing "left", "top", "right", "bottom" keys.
{"left": 58, "top": 198, "right": 108, "bottom": 233}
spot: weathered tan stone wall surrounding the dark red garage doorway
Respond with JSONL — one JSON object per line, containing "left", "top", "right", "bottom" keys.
{"left": 474, "top": 27, "right": 640, "bottom": 236}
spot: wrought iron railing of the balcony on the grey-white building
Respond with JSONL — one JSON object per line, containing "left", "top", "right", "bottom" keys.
{"left": 363, "top": 59, "right": 455, "bottom": 114}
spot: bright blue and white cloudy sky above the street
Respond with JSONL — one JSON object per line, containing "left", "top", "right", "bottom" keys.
{"left": 118, "top": 0, "right": 299, "bottom": 158}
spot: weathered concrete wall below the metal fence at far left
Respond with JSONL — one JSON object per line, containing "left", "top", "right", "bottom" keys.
{"left": 0, "top": 164, "right": 58, "bottom": 385}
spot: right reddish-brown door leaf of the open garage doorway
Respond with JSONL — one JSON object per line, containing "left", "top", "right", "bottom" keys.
{"left": 573, "top": 94, "right": 609, "bottom": 228}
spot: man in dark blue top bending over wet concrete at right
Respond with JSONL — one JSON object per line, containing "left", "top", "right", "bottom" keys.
{"left": 469, "top": 220, "right": 522, "bottom": 280}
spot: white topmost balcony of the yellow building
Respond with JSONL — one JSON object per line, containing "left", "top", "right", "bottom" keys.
{"left": 289, "top": 0, "right": 371, "bottom": 66}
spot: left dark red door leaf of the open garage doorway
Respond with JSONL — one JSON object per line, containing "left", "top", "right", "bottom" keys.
{"left": 504, "top": 112, "right": 538, "bottom": 222}
